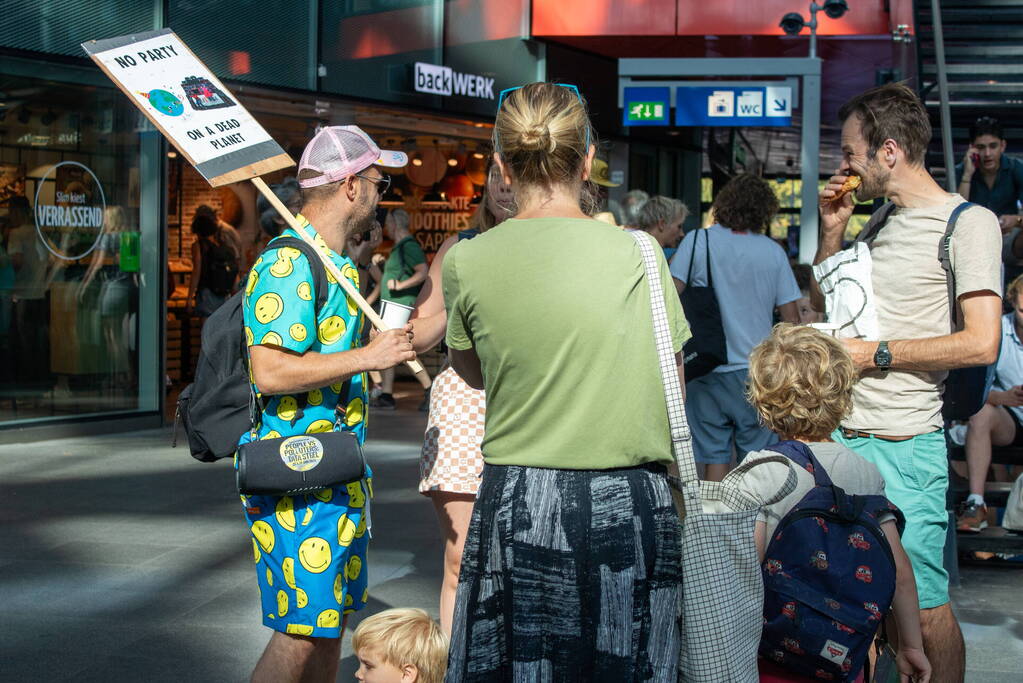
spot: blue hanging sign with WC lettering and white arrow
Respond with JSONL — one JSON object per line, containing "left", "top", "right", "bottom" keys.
{"left": 675, "top": 86, "right": 792, "bottom": 126}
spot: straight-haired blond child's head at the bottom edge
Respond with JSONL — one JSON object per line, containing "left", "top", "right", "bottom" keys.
{"left": 352, "top": 607, "right": 448, "bottom": 683}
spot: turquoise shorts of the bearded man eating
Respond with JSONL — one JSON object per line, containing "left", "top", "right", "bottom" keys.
{"left": 832, "top": 431, "right": 948, "bottom": 609}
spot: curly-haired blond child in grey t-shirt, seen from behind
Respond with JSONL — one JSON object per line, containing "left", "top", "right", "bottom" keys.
{"left": 740, "top": 323, "right": 931, "bottom": 682}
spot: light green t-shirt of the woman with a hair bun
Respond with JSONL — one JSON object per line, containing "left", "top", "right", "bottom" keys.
{"left": 443, "top": 218, "right": 692, "bottom": 469}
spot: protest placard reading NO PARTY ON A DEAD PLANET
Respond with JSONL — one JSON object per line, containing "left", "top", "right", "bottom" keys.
{"left": 82, "top": 29, "right": 295, "bottom": 187}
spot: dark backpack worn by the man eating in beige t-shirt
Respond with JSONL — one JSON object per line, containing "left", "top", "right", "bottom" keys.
{"left": 860, "top": 201, "right": 1000, "bottom": 421}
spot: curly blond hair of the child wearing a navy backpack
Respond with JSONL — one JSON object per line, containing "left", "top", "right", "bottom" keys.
{"left": 747, "top": 323, "right": 856, "bottom": 441}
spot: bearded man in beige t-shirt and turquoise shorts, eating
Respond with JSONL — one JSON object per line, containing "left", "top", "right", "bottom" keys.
{"left": 813, "top": 84, "right": 1002, "bottom": 683}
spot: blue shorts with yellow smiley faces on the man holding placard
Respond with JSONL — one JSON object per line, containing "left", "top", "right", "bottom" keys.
{"left": 241, "top": 479, "right": 372, "bottom": 638}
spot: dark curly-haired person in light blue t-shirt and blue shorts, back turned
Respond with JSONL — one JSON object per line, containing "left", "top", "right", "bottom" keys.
{"left": 671, "top": 174, "right": 802, "bottom": 482}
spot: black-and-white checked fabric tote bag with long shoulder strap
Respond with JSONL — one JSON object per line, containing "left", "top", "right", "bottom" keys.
{"left": 632, "top": 231, "right": 796, "bottom": 683}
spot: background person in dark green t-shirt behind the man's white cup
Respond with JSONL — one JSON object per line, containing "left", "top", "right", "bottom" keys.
{"left": 369, "top": 209, "right": 428, "bottom": 410}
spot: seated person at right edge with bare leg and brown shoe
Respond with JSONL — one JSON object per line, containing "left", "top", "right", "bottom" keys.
{"left": 951, "top": 275, "right": 1023, "bottom": 532}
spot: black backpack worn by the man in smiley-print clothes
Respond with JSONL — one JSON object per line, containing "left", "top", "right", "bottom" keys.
{"left": 174, "top": 236, "right": 329, "bottom": 462}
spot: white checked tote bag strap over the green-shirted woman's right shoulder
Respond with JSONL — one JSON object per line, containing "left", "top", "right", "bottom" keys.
{"left": 630, "top": 230, "right": 700, "bottom": 484}
